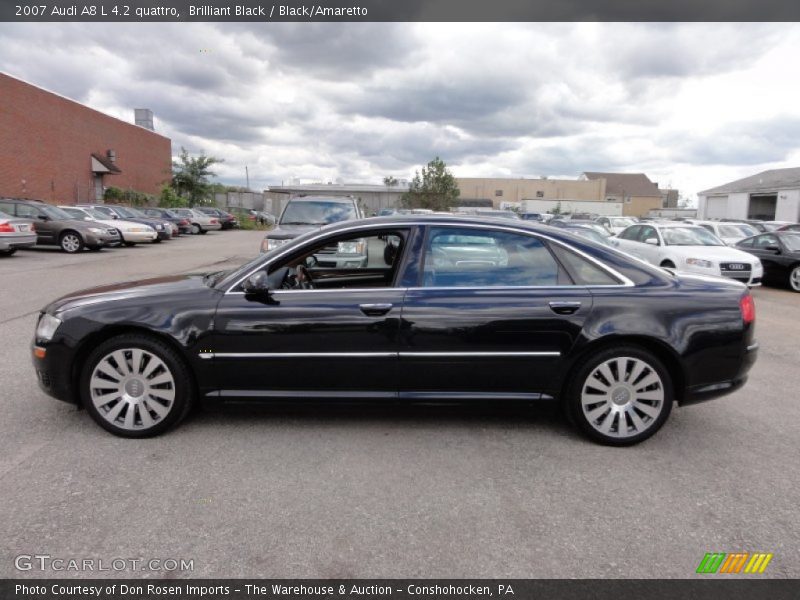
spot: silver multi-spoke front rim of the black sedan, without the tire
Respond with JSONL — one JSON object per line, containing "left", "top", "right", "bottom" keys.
{"left": 89, "top": 348, "right": 175, "bottom": 431}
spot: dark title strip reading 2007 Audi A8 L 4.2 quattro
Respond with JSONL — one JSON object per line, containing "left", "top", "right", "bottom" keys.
{"left": 0, "top": 0, "right": 800, "bottom": 22}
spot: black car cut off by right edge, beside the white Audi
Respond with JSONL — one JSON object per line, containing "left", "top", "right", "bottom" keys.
{"left": 736, "top": 230, "right": 800, "bottom": 292}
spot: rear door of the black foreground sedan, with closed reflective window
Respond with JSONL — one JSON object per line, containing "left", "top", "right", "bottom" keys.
{"left": 399, "top": 226, "right": 592, "bottom": 399}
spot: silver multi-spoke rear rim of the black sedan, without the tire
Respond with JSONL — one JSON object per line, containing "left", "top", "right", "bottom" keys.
{"left": 581, "top": 356, "right": 665, "bottom": 439}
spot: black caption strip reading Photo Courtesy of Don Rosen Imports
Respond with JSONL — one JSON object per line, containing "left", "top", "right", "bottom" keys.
{"left": 0, "top": 576, "right": 800, "bottom": 600}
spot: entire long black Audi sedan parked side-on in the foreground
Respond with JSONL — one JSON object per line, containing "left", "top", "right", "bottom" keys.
{"left": 33, "top": 215, "right": 758, "bottom": 445}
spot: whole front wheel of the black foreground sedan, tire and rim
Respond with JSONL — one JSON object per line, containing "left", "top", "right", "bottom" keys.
{"left": 80, "top": 334, "right": 194, "bottom": 438}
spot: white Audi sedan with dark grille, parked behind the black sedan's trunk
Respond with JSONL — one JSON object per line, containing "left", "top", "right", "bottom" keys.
{"left": 612, "top": 222, "right": 764, "bottom": 286}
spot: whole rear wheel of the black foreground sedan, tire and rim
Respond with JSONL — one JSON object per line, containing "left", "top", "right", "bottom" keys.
{"left": 565, "top": 346, "right": 674, "bottom": 446}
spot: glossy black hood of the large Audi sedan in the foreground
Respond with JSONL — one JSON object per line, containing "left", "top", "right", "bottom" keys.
{"left": 44, "top": 274, "right": 213, "bottom": 314}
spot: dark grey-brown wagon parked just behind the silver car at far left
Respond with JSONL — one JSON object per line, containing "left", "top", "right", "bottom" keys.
{"left": 0, "top": 198, "right": 122, "bottom": 254}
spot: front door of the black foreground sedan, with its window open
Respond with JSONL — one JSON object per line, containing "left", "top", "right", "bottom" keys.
{"left": 205, "top": 230, "right": 407, "bottom": 399}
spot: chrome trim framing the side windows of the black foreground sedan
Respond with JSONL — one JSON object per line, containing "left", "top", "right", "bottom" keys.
{"left": 224, "top": 221, "right": 635, "bottom": 296}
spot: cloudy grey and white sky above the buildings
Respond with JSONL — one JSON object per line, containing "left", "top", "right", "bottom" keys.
{"left": 0, "top": 23, "right": 800, "bottom": 197}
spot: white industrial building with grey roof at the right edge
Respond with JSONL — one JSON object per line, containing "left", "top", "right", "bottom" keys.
{"left": 697, "top": 168, "right": 800, "bottom": 223}
